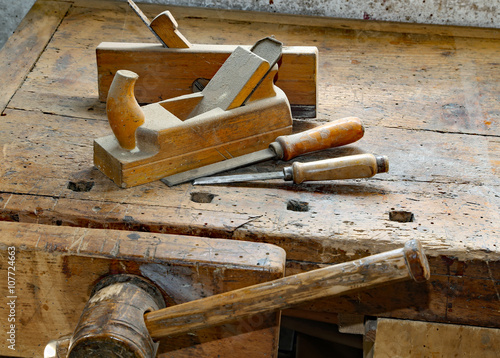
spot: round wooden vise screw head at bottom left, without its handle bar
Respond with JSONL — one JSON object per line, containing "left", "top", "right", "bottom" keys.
{"left": 68, "top": 274, "right": 165, "bottom": 358}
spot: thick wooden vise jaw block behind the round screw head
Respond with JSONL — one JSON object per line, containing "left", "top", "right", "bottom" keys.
{"left": 0, "top": 222, "right": 285, "bottom": 357}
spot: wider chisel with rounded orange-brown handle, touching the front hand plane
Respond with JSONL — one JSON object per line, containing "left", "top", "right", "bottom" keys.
{"left": 161, "top": 117, "right": 364, "bottom": 186}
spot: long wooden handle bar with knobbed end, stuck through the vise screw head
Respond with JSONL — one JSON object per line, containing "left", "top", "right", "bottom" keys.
{"left": 144, "top": 240, "right": 429, "bottom": 339}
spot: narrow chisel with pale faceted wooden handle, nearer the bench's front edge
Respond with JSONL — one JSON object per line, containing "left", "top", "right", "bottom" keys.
{"left": 193, "top": 153, "right": 389, "bottom": 185}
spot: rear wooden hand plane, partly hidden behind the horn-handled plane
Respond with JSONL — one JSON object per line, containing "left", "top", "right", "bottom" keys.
{"left": 96, "top": 0, "right": 318, "bottom": 118}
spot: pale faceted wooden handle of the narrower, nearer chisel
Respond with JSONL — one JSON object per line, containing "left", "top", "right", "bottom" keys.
{"left": 290, "top": 153, "right": 389, "bottom": 184}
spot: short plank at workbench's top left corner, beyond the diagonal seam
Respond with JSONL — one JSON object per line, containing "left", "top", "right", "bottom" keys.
{"left": 0, "top": 0, "right": 71, "bottom": 112}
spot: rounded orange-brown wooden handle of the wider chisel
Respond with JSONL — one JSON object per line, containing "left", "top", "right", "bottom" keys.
{"left": 271, "top": 117, "right": 365, "bottom": 160}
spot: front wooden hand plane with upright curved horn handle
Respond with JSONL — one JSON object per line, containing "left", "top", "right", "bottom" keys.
{"left": 94, "top": 38, "right": 292, "bottom": 188}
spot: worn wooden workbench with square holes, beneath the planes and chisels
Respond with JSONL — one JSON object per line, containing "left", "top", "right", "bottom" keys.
{"left": 0, "top": 0, "right": 500, "bottom": 346}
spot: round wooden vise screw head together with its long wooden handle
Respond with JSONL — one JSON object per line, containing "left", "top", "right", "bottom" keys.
{"left": 63, "top": 240, "right": 430, "bottom": 358}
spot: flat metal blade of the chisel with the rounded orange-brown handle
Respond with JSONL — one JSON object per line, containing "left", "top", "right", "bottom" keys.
{"left": 161, "top": 148, "right": 276, "bottom": 186}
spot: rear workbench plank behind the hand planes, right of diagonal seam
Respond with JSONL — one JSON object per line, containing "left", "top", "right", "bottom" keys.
{"left": 11, "top": 2, "right": 500, "bottom": 136}
